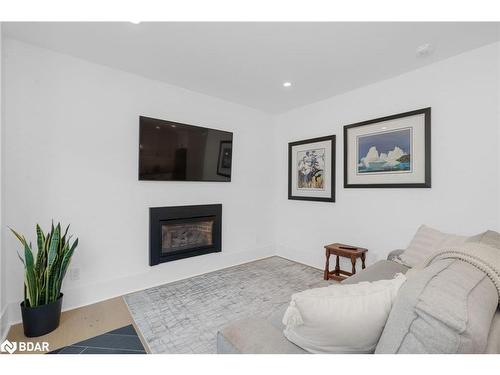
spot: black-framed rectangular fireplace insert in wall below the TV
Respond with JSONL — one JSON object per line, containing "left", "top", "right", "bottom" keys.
{"left": 149, "top": 204, "right": 222, "bottom": 266}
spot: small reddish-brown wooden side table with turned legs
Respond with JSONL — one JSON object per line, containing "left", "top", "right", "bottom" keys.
{"left": 324, "top": 243, "right": 368, "bottom": 281}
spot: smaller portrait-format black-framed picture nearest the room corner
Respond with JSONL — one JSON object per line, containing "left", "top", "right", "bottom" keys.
{"left": 288, "top": 135, "right": 335, "bottom": 202}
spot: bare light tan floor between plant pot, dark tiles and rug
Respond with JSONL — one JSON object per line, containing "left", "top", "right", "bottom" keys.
{"left": 7, "top": 297, "right": 150, "bottom": 353}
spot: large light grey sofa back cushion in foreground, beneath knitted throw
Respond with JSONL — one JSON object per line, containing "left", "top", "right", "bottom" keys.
{"left": 375, "top": 259, "right": 498, "bottom": 354}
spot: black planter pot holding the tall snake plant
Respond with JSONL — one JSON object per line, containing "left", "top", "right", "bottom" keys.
{"left": 21, "top": 293, "right": 63, "bottom": 337}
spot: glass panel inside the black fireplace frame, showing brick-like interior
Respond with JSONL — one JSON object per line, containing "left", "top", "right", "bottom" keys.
{"left": 161, "top": 217, "right": 215, "bottom": 254}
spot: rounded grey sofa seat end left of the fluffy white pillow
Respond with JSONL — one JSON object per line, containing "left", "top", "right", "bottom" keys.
{"left": 217, "top": 318, "right": 305, "bottom": 354}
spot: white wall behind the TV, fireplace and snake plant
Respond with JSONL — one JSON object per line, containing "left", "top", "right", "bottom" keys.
{"left": 4, "top": 39, "right": 275, "bottom": 324}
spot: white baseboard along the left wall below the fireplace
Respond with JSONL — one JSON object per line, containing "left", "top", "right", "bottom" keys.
{"left": 2, "top": 245, "right": 276, "bottom": 330}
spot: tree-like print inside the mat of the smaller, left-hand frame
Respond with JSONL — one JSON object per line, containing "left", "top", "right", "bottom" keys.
{"left": 297, "top": 148, "right": 325, "bottom": 189}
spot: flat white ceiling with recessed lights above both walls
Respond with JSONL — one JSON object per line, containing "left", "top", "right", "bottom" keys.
{"left": 4, "top": 22, "right": 500, "bottom": 113}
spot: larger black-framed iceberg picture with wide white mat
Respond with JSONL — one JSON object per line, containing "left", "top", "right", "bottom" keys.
{"left": 344, "top": 108, "right": 431, "bottom": 188}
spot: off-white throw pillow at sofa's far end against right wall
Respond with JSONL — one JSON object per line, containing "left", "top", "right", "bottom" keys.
{"left": 396, "top": 225, "right": 467, "bottom": 267}
